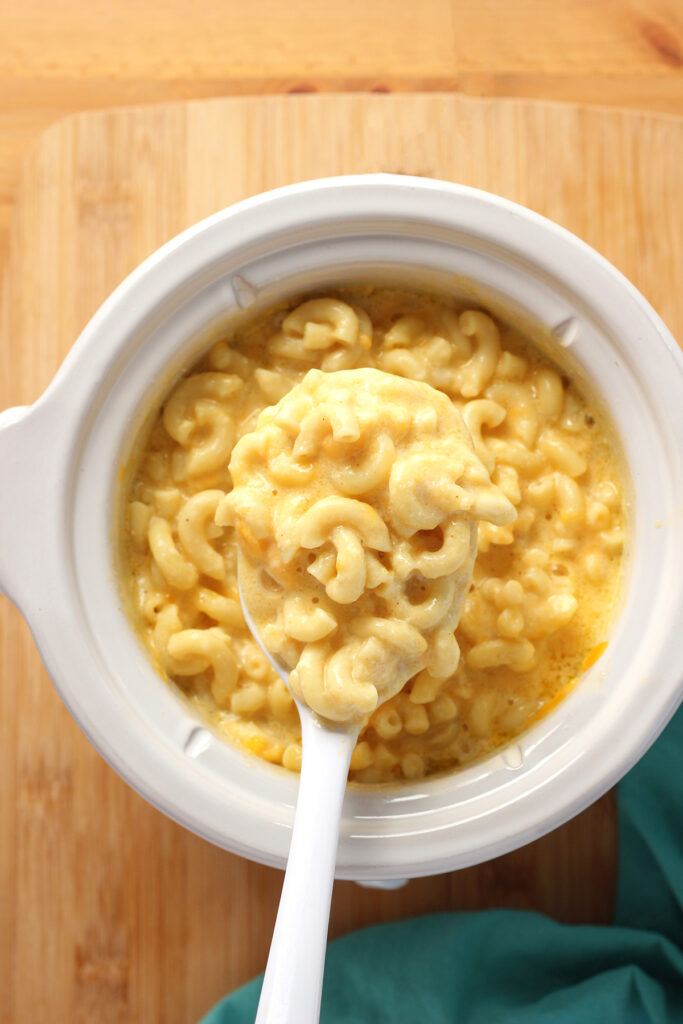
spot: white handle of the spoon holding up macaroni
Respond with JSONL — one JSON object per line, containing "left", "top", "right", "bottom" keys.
{"left": 256, "top": 710, "right": 356, "bottom": 1024}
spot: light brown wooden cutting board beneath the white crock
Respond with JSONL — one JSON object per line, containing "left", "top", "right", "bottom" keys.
{"left": 0, "top": 94, "right": 683, "bottom": 1024}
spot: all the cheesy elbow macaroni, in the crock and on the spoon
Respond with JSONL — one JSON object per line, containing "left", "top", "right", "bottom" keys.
{"left": 123, "top": 289, "right": 625, "bottom": 782}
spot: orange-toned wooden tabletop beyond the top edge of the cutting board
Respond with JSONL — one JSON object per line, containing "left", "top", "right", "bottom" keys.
{"left": 0, "top": 0, "right": 683, "bottom": 272}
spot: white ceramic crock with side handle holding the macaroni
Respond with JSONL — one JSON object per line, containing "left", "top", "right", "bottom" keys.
{"left": 0, "top": 175, "right": 683, "bottom": 880}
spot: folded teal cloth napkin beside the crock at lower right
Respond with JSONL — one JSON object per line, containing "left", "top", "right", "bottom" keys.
{"left": 202, "top": 708, "right": 683, "bottom": 1024}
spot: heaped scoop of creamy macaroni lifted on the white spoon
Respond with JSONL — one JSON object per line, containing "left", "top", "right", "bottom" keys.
{"left": 222, "top": 369, "right": 516, "bottom": 722}
